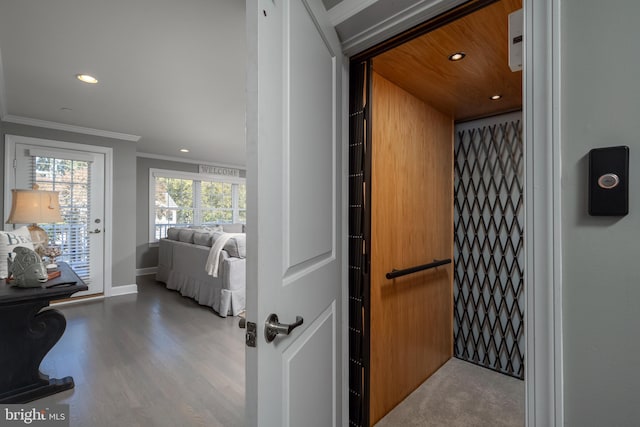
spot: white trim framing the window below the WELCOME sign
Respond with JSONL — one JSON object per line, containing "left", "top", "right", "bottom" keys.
{"left": 148, "top": 168, "right": 246, "bottom": 246}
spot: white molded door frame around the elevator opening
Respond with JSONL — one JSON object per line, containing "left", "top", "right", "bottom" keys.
{"left": 329, "top": 0, "right": 564, "bottom": 427}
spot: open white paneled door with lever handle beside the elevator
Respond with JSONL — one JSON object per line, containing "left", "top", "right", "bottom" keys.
{"left": 247, "top": 0, "right": 347, "bottom": 427}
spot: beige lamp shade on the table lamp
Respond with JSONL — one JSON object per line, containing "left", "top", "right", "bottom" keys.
{"left": 7, "top": 190, "right": 63, "bottom": 224}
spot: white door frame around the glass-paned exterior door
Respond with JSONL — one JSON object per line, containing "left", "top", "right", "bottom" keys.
{"left": 4, "top": 134, "right": 113, "bottom": 297}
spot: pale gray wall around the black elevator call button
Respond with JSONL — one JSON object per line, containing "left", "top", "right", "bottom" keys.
{"left": 561, "top": 0, "right": 640, "bottom": 427}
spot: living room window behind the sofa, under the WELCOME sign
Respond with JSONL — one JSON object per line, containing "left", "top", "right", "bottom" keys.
{"left": 149, "top": 169, "right": 247, "bottom": 242}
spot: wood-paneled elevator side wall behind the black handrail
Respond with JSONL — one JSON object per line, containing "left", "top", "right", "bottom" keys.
{"left": 370, "top": 71, "right": 453, "bottom": 424}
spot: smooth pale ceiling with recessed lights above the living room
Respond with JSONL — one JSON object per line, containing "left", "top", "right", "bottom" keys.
{"left": 0, "top": 0, "right": 246, "bottom": 166}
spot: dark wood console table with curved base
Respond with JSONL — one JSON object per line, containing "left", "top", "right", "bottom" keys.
{"left": 0, "top": 262, "right": 88, "bottom": 403}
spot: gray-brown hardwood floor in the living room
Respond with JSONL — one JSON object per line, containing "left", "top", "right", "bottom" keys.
{"left": 37, "top": 276, "right": 245, "bottom": 427}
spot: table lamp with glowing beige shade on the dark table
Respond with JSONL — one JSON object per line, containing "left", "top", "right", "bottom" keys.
{"left": 7, "top": 184, "right": 63, "bottom": 256}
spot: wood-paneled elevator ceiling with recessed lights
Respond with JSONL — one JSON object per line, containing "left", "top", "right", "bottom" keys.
{"left": 373, "top": 0, "right": 522, "bottom": 120}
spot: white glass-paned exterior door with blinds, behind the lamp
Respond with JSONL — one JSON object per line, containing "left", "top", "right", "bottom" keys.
{"left": 5, "top": 143, "right": 105, "bottom": 297}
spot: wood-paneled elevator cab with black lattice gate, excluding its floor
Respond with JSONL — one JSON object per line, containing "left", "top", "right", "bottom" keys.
{"left": 349, "top": 0, "right": 524, "bottom": 426}
